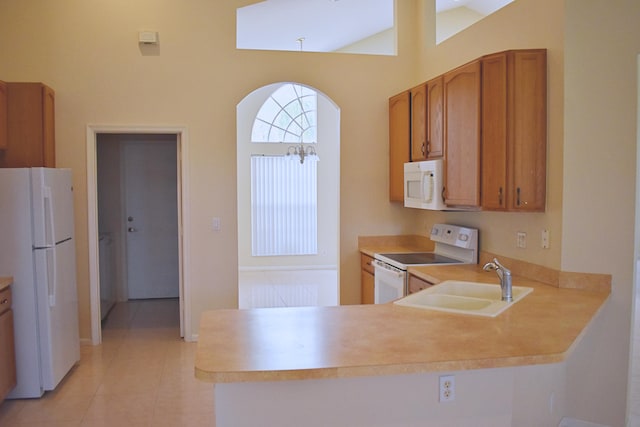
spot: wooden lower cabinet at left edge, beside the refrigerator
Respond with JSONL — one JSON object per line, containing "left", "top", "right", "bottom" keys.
{"left": 0, "top": 287, "right": 16, "bottom": 402}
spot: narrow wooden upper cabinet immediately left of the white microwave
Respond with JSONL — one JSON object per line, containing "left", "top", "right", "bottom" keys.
{"left": 389, "top": 90, "right": 411, "bottom": 202}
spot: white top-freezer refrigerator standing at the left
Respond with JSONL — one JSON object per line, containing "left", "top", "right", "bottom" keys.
{"left": 0, "top": 168, "right": 80, "bottom": 399}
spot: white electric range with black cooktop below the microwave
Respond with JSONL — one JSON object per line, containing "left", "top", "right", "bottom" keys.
{"left": 373, "top": 224, "right": 478, "bottom": 304}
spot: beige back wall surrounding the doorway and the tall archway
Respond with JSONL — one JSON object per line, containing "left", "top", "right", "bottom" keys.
{"left": 0, "top": 0, "right": 416, "bottom": 338}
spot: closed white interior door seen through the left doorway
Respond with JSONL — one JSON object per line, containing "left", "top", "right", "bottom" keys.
{"left": 123, "top": 142, "right": 179, "bottom": 299}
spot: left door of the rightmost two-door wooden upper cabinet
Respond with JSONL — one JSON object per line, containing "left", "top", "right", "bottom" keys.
{"left": 482, "top": 53, "right": 507, "bottom": 210}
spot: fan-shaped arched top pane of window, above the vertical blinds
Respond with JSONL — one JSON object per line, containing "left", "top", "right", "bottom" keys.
{"left": 251, "top": 83, "right": 318, "bottom": 144}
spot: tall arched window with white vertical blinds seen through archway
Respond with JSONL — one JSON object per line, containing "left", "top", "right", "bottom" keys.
{"left": 251, "top": 83, "right": 318, "bottom": 256}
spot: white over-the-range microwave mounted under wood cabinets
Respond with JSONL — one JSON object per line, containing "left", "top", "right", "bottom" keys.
{"left": 404, "top": 159, "right": 447, "bottom": 211}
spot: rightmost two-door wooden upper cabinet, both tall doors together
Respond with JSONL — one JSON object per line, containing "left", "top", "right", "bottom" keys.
{"left": 482, "top": 49, "right": 547, "bottom": 212}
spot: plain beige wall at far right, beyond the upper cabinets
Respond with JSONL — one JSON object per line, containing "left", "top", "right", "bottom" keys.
{"left": 562, "top": 0, "right": 640, "bottom": 425}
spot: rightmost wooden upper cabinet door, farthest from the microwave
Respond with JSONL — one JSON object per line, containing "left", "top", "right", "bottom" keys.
{"left": 508, "top": 49, "right": 547, "bottom": 212}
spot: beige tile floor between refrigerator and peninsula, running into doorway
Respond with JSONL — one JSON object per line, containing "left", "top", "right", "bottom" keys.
{"left": 0, "top": 300, "right": 214, "bottom": 427}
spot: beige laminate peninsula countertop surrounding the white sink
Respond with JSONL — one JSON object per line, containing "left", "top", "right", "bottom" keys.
{"left": 195, "top": 265, "right": 609, "bottom": 383}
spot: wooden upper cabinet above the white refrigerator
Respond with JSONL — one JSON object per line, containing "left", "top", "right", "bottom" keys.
{"left": 0, "top": 83, "right": 55, "bottom": 167}
